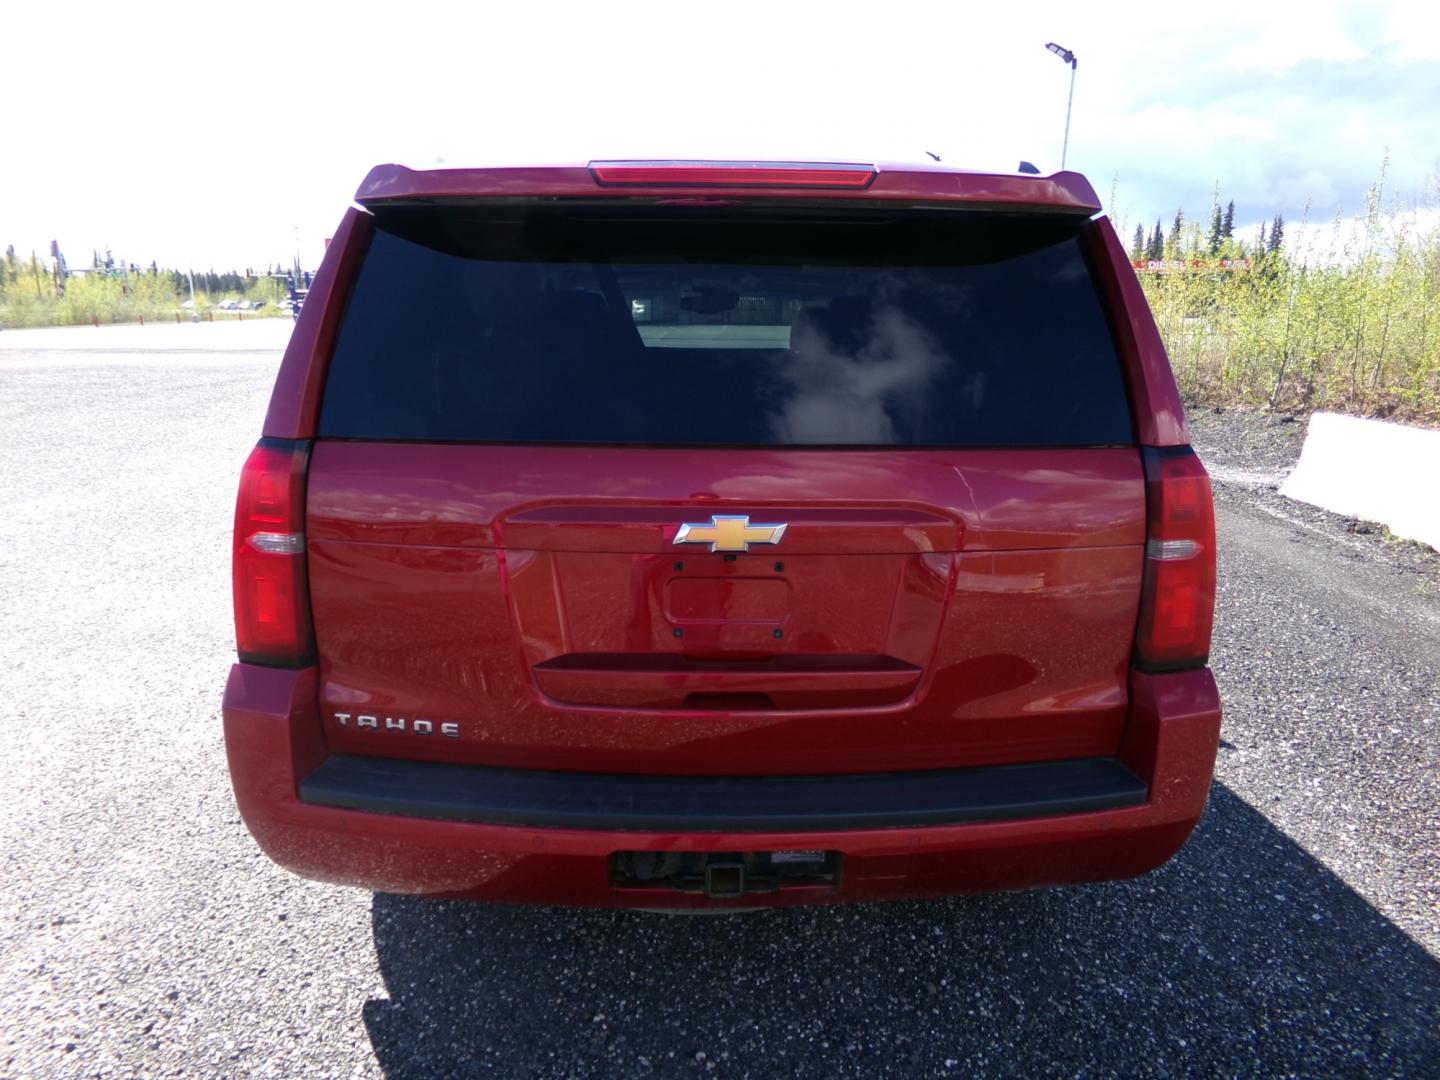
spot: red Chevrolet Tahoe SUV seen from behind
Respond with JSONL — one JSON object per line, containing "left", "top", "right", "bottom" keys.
{"left": 225, "top": 161, "right": 1220, "bottom": 909}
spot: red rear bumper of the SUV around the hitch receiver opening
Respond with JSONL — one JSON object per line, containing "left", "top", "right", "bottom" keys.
{"left": 225, "top": 664, "right": 1220, "bottom": 907}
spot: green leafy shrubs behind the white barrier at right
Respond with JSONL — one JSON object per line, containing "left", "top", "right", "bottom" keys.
{"left": 1140, "top": 171, "right": 1440, "bottom": 422}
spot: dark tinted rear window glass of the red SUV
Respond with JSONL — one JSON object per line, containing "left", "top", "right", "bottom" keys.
{"left": 320, "top": 207, "right": 1133, "bottom": 446}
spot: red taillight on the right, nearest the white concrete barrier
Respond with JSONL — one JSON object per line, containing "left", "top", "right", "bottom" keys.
{"left": 1135, "top": 446, "right": 1215, "bottom": 671}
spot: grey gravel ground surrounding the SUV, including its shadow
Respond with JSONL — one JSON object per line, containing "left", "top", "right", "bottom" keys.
{"left": 0, "top": 332, "right": 1440, "bottom": 1077}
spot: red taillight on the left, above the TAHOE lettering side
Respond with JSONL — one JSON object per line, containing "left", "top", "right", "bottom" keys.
{"left": 233, "top": 439, "right": 314, "bottom": 667}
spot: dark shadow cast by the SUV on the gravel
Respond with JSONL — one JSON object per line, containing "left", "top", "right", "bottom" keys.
{"left": 364, "top": 785, "right": 1440, "bottom": 1077}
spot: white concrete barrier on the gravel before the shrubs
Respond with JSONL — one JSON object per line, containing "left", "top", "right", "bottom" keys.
{"left": 1280, "top": 412, "right": 1440, "bottom": 549}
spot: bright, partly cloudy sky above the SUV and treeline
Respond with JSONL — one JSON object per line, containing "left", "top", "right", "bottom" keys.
{"left": 0, "top": 0, "right": 1440, "bottom": 269}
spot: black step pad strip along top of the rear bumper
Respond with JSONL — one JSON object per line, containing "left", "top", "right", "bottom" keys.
{"left": 300, "top": 755, "right": 1146, "bottom": 832}
